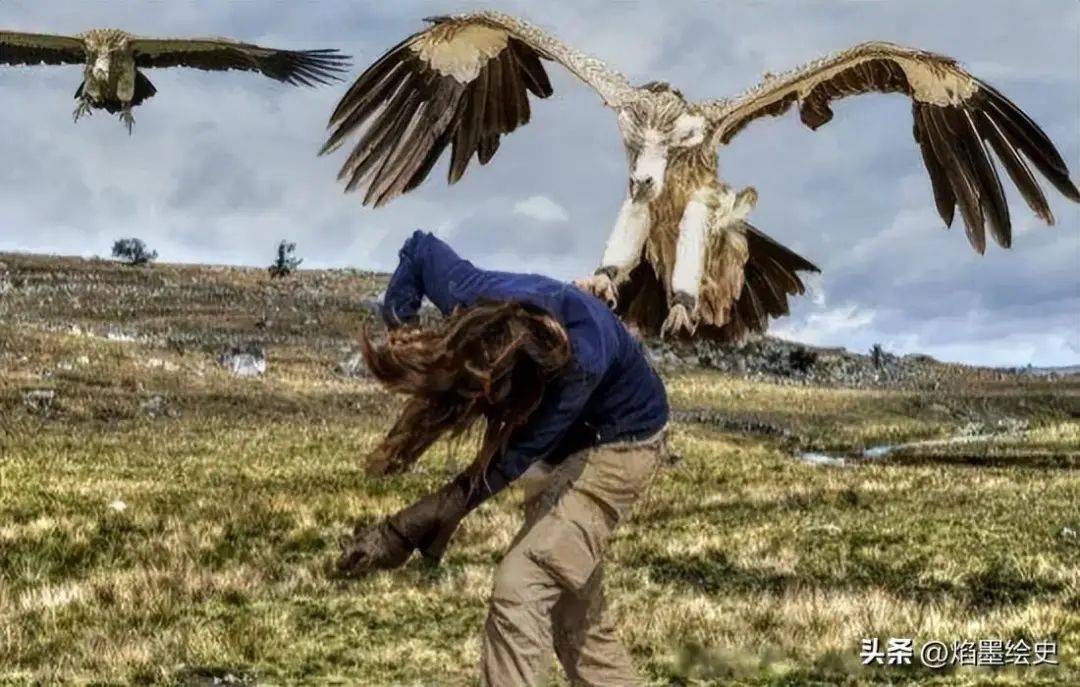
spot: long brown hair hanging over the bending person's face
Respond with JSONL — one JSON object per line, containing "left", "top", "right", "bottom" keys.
{"left": 361, "top": 302, "right": 570, "bottom": 480}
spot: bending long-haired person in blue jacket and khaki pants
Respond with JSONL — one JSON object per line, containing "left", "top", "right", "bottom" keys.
{"left": 338, "top": 231, "right": 669, "bottom": 686}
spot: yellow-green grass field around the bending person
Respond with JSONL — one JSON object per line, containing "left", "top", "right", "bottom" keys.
{"left": 0, "top": 255, "right": 1080, "bottom": 685}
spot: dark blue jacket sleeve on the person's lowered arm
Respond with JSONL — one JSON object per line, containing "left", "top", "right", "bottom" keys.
{"left": 470, "top": 364, "right": 600, "bottom": 500}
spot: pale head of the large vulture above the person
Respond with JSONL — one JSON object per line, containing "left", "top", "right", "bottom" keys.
{"left": 619, "top": 81, "right": 707, "bottom": 202}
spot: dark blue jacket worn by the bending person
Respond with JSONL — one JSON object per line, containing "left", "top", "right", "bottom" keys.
{"left": 382, "top": 230, "right": 667, "bottom": 482}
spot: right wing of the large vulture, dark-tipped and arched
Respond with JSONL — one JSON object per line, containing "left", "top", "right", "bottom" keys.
{"left": 706, "top": 42, "right": 1080, "bottom": 253}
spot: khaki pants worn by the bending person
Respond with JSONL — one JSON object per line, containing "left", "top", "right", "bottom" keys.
{"left": 481, "top": 432, "right": 666, "bottom": 687}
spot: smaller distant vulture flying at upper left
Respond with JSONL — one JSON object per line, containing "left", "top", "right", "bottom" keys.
{"left": 0, "top": 29, "right": 349, "bottom": 132}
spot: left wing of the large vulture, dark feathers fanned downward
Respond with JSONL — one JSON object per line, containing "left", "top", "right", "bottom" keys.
{"left": 322, "top": 12, "right": 633, "bottom": 206}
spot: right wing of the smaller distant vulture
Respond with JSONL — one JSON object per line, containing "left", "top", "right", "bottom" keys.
{"left": 129, "top": 38, "right": 349, "bottom": 85}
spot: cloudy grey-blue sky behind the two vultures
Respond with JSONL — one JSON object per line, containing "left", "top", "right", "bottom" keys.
{"left": 0, "top": 0, "right": 1080, "bottom": 365}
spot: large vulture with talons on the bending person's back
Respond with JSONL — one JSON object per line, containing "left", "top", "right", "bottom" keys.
{"left": 323, "top": 12, "right": 1080, "bottom": 340}
